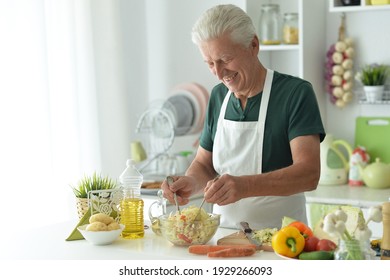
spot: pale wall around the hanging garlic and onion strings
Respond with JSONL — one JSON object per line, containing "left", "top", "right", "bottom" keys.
{"left": 324, "top": 10, "right": 390, "bottom": 145}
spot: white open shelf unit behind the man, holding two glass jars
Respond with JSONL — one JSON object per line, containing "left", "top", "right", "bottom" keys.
{"left": 247, "top": 0, "right": 327, "bottom": 92}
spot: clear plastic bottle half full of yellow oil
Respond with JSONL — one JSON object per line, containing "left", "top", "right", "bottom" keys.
{"left": 119, "top": 159, "right": 145, "bottom": 239}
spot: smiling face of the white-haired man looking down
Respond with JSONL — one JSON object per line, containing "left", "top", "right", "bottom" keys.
{"left": 199, "top": 34, "right": 261, "bottom": 97}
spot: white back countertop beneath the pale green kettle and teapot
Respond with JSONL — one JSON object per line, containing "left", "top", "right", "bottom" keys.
{"left": 305, "top": 185, "right": 390, "bottom": 208}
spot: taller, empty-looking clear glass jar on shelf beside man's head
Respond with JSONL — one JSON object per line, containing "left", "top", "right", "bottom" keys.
{"left": 259, "top": 4, "right": 281, "bottom": 45}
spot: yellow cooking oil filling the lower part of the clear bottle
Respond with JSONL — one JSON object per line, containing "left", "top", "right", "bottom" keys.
{"left": 121, "top": 198, "right": 145, "bottom": 239}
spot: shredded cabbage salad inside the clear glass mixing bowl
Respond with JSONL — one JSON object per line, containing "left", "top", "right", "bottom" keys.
{"left": 162, "top": 206, "right": 219, "bottom": 245}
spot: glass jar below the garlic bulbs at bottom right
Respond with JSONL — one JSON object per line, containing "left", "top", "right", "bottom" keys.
{"left": 334, "top": 239, "right": 376, "bottom": 260}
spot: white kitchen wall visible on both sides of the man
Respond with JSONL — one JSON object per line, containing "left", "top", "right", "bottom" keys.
{"left": 110, "top": 0, "right": 390, "bottom": 170}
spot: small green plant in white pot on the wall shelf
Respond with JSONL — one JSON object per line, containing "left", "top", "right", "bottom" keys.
{"left": 356, "top": 63, "right": 390, "bottom": 102}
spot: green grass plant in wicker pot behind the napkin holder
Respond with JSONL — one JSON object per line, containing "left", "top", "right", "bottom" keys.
{"left": 71, "top": 172, "right": 117, "bottom": 219}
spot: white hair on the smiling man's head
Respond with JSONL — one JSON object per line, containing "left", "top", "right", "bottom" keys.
{"left": 192, "top": 4, "right": 256, "bottom": 47}
